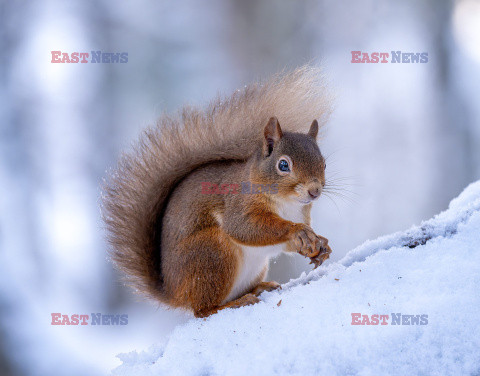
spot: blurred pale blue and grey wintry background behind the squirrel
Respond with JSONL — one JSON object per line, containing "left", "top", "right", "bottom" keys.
{"left": 0, "top": 0, "right": 480, "bottom": 376}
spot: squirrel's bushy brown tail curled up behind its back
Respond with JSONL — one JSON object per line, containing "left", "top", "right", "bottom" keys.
{"left": 103, "top": 66, "right": 331, "bottom": 301}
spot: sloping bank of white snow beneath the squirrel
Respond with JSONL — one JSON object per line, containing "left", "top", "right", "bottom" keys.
{"left": 113, "top": 181, "right": 480, "bottom": 376}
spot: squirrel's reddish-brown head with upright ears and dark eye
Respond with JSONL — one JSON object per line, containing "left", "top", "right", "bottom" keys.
{"left": 251, "top": 117, "right": 325, "bottom": 204}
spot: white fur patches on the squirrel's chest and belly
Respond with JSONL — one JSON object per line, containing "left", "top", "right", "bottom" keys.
{"left": 224, "top": 202, "right": 305, "bottom": 303}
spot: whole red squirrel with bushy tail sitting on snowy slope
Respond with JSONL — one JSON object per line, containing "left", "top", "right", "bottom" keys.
{"left": 103, "top": 66, "right": 331, "bottom": 317}
